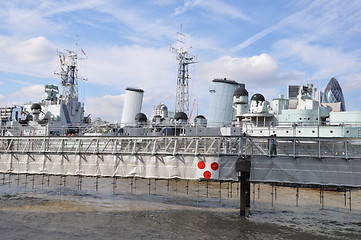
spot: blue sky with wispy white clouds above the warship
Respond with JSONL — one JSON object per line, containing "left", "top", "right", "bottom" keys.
{"left": 0, "top": 0, "right": 361, "bottom": 122}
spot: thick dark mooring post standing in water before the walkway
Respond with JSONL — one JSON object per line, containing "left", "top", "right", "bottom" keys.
{"left": 236, "top": 157, "right": 251, "bottom": 216}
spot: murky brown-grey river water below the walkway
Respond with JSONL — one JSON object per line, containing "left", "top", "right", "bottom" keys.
{"left": 0, "top": 175, "right": 361, "bottom": 240}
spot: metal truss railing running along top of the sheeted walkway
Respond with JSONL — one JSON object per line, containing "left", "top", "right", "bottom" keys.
{"left": 0, "top": 136, "right": 361, "bottom": 159}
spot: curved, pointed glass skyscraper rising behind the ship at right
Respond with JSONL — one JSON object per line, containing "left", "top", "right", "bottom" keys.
{"left": 321, "top": 78, "right": 346, "bottom": 111}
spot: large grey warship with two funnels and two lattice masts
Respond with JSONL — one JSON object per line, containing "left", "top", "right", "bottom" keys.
{"left": 0, "top": 42, "right": 361, "bottom": 138}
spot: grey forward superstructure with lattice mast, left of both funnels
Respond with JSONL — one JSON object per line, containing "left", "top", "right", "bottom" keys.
{"left": 5, "top": 50, "right": 87, "bottom": 136}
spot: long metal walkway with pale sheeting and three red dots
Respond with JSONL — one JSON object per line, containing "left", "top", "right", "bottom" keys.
{"left": 0, "top": 136, "right": 361, "bottom": 187}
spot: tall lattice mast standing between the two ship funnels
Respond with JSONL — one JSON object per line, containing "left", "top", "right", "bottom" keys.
{"left": 171, "top": 32, "right": 196, "bottom": 114}
